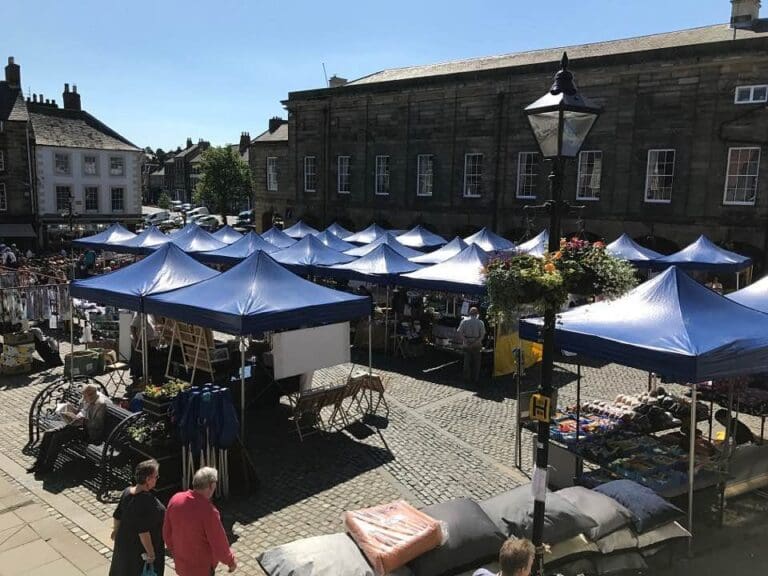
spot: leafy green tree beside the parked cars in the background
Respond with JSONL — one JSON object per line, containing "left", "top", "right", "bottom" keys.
{"left": 193, "top": 146, "right": 251, "bottom": 222}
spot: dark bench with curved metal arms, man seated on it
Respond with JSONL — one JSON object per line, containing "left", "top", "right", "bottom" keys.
{"left": 26, "top": 378, "right": 147, "bottom": 500}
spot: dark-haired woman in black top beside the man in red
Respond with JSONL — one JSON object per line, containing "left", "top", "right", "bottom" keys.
{"left": 109, "top": 460, "right": 165, "bottom": 576}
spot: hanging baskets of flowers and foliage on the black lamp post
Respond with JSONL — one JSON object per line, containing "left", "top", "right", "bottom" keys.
{"left": 486, "top": 238, "right": 637, "bottom": 320}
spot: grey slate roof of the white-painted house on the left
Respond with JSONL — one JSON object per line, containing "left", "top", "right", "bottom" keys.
{"left": 26, "top": 102, "right": 140, "bottom": 151}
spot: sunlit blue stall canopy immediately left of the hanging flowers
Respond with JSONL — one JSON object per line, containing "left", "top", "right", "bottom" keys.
{"left": 401, "top": 244, "right": 489, "bottom": 294}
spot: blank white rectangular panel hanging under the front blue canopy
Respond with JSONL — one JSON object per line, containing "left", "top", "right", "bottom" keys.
{"left": 272, "top": 322, "right": 351, "bottom": 380}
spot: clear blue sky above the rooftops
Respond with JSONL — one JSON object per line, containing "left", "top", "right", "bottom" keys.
{"left": 6, "top": 0, "right": 731, "bottom": 149}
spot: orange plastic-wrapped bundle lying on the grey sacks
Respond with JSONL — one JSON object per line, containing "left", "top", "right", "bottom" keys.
{"left": 344, "top": 500, "right": 443, "bottom": 576}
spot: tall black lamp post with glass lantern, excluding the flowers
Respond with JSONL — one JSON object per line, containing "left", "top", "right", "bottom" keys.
{"left": 525, "top": 53, "right": 601, "bottom": 574}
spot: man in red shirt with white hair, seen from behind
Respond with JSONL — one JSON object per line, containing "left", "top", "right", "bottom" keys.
{"left": 163, "top": 467, "right": 237, "bottom": 576}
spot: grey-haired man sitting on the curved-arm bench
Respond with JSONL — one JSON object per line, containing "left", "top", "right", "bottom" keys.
{"left": 27, "top": 384, "right": 109, "bottom": 474}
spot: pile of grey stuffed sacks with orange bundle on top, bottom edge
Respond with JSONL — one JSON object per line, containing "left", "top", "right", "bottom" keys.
{"left": 259, "top": 480, "right": 690, "bottom": 576}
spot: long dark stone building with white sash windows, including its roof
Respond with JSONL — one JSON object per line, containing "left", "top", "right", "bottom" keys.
{"left": 280, "top": 0, "right": 768, "bottom": 258}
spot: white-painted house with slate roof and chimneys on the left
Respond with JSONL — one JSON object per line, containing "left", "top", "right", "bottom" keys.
{"left": 27, "top": 85, "right": 144, "bottom": 243}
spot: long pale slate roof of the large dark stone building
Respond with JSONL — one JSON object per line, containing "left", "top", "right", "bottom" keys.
{"left": 346, "top": 21, "right": 768, "bottom": 86}
